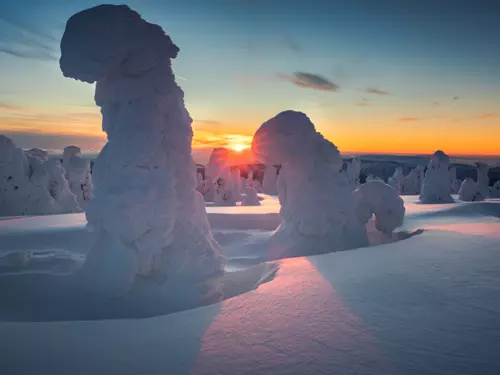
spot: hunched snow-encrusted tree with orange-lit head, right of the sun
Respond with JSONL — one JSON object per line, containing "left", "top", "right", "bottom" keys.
{"left": 252, "top": 111, "right": 376, "bottom": 259}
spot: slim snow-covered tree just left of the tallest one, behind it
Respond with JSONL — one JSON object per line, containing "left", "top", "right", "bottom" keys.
{"left": 62, "top": 146, "right": 92, "bottom": 208}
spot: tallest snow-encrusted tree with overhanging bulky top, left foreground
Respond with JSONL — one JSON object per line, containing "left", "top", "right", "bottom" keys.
{"left": 60, "top": 5, "right": 224, "bottom": 300}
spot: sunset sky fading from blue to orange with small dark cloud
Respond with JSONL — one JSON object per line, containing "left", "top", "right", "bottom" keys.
{"left": 0, "top": 0, "right": 500, "bottom": 164}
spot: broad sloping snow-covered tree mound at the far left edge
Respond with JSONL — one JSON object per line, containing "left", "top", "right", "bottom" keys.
{"left": 0, "top": 135, "right": 81, "bottom": 216}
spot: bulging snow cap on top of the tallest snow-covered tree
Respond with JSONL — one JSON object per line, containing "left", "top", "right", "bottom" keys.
{"left": 60, "top": 4, "right": 179, "bottom": 83}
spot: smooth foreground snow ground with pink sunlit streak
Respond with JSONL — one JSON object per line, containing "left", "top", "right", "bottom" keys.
{"left": 0, "top": 196, "right": 500, "bottom": 375}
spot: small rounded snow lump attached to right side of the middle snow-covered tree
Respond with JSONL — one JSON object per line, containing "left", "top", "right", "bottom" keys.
{"left": 354, "top": 181, "right": 405, "bottom": 235}
